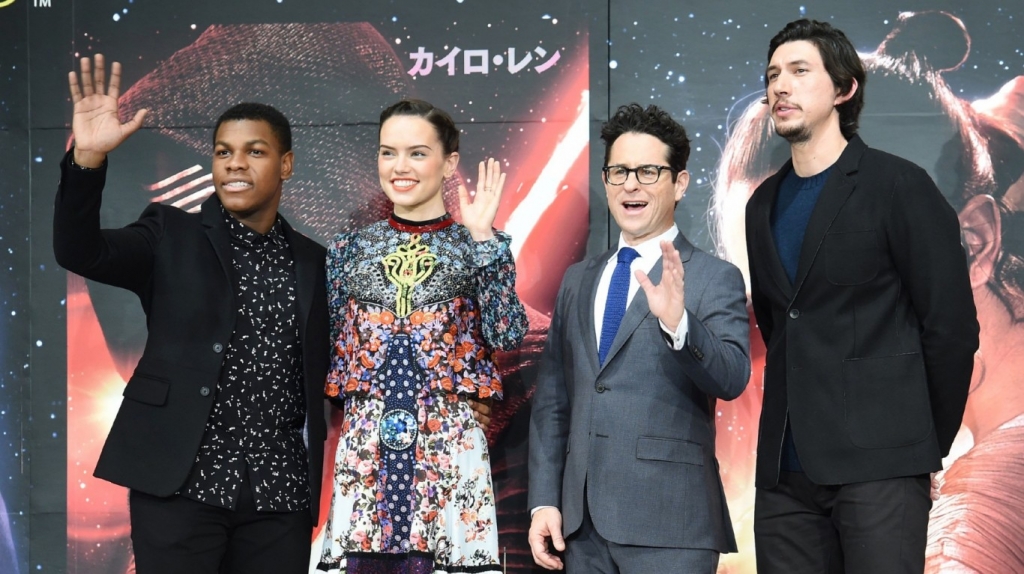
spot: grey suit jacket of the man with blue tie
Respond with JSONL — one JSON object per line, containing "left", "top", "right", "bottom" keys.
{"left": 528, "top": 234, "right": 751, "bottom": 553}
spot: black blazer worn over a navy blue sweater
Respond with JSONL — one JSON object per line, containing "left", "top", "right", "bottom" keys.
{"left": 746, "top": 137, "right": 979, "bottom": 488}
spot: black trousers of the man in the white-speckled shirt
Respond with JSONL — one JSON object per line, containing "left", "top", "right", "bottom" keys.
{"left": 128, "top": 470, "right": 312, "bottom": 574}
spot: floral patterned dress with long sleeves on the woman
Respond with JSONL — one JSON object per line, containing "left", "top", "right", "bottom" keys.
{"left": 319, "top": 216, "right": 527, "bottom": 574}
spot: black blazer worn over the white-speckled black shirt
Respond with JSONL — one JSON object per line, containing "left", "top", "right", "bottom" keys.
{"left": 53, "top": 152, "right": 330, "bottom": 523}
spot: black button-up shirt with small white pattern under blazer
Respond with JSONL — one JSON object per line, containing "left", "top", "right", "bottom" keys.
{"left": 180, "top": 211, "right": 310, "bottom": 512}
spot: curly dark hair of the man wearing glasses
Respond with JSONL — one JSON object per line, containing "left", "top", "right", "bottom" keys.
{"left": 601, "top": 102, "right": 690, "bottom": 175}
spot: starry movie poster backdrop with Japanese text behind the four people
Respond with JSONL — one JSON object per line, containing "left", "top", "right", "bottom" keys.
{"left": 9, "top": 0, "right": 1024, "bottom": 574}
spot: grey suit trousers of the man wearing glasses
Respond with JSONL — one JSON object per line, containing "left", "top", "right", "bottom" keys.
{"left": 565, "top": 492, "right": 719, "bottom": 574}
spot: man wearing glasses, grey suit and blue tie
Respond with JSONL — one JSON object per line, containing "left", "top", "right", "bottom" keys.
{"left": 528, "top": 103, "right": 750, "bottom": 574}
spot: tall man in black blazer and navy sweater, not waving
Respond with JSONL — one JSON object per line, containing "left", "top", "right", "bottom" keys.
{"left": 745, "top": 19, "right": 979, "bottom": 574}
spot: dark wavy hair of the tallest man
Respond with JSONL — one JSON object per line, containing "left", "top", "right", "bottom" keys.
{"left": 762, "top": 18, "right": 867, "bottom": 139}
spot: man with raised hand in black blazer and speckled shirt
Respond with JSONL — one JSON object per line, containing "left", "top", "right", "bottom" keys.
{"left": 53, "top": 54, "right": 330, "bottom": 574}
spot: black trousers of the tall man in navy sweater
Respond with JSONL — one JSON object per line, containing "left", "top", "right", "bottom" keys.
{"left": 754, "top": 471, "right": 932, "bottom": 574}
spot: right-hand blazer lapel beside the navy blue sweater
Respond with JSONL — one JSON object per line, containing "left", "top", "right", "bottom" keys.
{"left": 794, "top": 136, "right": 867, "bottom": 296}
